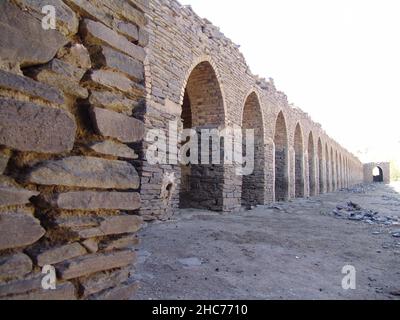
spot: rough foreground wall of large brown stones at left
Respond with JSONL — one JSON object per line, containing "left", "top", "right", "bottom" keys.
{"left": 0, "top": 0, "right": 149, "bottom": 299}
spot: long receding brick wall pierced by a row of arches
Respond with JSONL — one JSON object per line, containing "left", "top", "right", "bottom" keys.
{"left": 140, "top": 0, "right": 363, "bottom": 220}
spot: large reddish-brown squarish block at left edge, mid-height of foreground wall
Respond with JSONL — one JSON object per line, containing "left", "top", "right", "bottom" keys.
{"left": 0, "top": 98, "right": 77, "bottom": 153}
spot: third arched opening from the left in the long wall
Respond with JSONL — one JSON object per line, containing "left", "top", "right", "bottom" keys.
{"left": 274, "top": 112, "right": 289, "bottom": 201}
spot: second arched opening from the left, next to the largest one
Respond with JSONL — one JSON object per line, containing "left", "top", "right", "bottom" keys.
{"left": 242, "top": 92, "right": 265, "bottom": 206}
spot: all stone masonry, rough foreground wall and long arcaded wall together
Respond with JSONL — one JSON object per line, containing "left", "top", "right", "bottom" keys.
{"left": 0, "top": 0, "right": 386, "bottom": 299}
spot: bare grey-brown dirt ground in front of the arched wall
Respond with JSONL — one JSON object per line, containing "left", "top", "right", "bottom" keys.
{"left": 133, "top": 184, "right": 400, "bottom": 300}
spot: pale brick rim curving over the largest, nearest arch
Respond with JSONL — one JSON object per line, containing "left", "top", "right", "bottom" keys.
{"left": 179, "top": 55, "right": 228, "bottom": 125}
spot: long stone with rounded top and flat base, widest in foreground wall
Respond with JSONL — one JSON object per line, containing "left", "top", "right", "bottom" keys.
{"left": 27, "top": 156, "right": 140, "bottom": 189}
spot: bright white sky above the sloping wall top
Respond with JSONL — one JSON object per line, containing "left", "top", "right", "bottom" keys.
{"left": 181, "top": 0, "right": 400, "bottom": 164}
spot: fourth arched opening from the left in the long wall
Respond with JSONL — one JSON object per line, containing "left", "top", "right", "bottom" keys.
{"left": 294, "top": 123, "right": 304, "bottom": 198}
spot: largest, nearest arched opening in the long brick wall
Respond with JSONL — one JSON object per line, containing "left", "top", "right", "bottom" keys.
{"left": 179, "top": 62, "right": 225, "bottom": 211}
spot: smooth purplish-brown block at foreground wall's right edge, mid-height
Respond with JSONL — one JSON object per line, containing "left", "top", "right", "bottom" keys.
{"left": 91, "top": 107, "right": 145, "bottom": 143}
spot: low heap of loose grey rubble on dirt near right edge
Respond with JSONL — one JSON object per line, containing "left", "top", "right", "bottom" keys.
{"left": 332, "top": 201, "right": 400, "bottom": 226}
